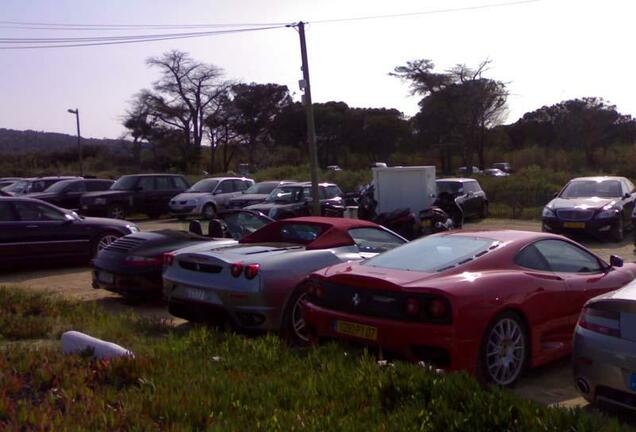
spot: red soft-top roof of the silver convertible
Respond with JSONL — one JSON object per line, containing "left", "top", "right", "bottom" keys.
{"left": 239, "top": 216, "right": 380, "bottom": 250}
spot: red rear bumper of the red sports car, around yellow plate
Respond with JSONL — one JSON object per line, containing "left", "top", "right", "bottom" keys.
{"left": 303, "top": 302, "right": 477, "bottom": 373}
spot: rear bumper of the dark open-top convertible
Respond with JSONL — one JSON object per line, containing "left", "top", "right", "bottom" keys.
{"left": 92, "top": 268, "right": 162, "bottom": 297}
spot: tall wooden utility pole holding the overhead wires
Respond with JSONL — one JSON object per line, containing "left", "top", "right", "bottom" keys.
{"left": 298, "top": 21, "right": 320, "bottom": 216}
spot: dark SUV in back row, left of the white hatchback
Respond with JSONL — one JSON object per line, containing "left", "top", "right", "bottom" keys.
{"left": 80, "top": 174, "right": 189, "bottom": 219}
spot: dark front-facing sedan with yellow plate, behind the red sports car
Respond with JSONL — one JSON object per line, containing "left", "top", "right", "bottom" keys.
{"left": 542, "top": 177, "right": 636, "bottom": 242}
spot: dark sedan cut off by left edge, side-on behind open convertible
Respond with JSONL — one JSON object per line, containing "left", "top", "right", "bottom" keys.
{"left": 0, "top": 197, "right": 139, "bottom": 265}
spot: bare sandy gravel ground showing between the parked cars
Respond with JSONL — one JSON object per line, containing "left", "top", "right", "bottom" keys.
{"left": 0, "top": 219, "right": 635, "bottom": 407}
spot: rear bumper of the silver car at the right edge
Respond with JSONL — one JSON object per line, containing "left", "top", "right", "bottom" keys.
{"left": 572, "top": 326, "right": 636, "bottom": 411}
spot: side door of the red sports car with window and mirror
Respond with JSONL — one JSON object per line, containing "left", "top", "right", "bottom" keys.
{"left": 535, "top": 239, "right": 630, "bottom": 329}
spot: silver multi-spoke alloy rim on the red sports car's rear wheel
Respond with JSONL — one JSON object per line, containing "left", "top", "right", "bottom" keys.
{"left": 486, "top": 318, "right": 526, "bottom": 386}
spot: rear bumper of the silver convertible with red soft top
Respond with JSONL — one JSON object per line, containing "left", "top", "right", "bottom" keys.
{"left": 163, "top": 277, "right": 281, "bottom": 331}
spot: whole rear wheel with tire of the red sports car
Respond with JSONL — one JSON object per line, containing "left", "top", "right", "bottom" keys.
{"left": 477, "top": 311, "right": 530, "bottom": 387}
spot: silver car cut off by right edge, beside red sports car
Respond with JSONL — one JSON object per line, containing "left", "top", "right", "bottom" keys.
{"left": 572, "top": 281, "right": 636, "bottom": 410}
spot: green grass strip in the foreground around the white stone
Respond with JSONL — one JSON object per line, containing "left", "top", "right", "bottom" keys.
{"left": 0, "top": 288, "right": 632, "bottom": 431}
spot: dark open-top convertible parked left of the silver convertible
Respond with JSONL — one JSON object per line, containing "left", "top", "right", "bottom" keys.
{"left": 93, "top": 210, "right": 273, "bottom": 300}
